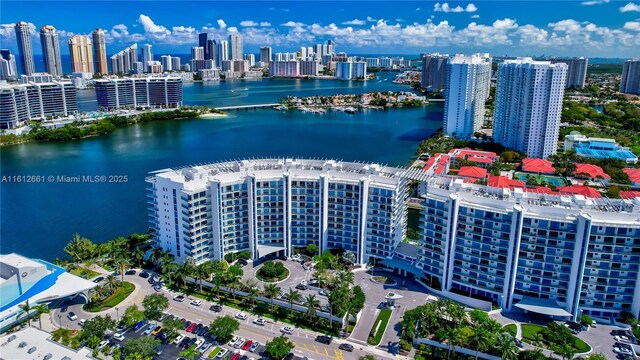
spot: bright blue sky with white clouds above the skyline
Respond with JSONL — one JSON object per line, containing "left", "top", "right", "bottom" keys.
{"left": 0, "top": 0, "right": 640, "bottom": 57}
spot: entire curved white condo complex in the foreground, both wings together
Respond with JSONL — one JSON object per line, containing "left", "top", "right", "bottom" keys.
{"left": 147, "top": 159, "right": 640, "bottom": 319}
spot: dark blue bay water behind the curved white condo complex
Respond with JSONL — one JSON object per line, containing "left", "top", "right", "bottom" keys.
{"left": 0, "top": 76, "right": 442, "bottom": 260}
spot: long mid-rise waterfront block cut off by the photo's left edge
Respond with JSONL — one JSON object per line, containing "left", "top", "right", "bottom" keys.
{"left": 0, "top": 80, "right": 78, "bottom": 129}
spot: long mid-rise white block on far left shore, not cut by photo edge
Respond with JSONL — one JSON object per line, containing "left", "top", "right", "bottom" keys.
{"left": 95, "top": 75, "right": 182, "bottom": 110}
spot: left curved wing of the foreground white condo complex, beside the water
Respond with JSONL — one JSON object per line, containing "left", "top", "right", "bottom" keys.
{"left": 147, "top": 159, "right": 406, "bottom": 264}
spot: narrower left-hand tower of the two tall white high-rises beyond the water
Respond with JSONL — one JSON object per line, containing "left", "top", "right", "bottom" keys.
{"left": 443, "top": 54, "right": 491, "bottom": 139}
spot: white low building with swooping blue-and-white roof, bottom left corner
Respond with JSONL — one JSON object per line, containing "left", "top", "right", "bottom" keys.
{"left": 0, "top": 254, "right": 97, "bottom": 332}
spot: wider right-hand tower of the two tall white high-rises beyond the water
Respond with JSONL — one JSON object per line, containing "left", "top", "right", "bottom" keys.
{"left": 493, "top": 58, "right": 567, "bottom": 159}
